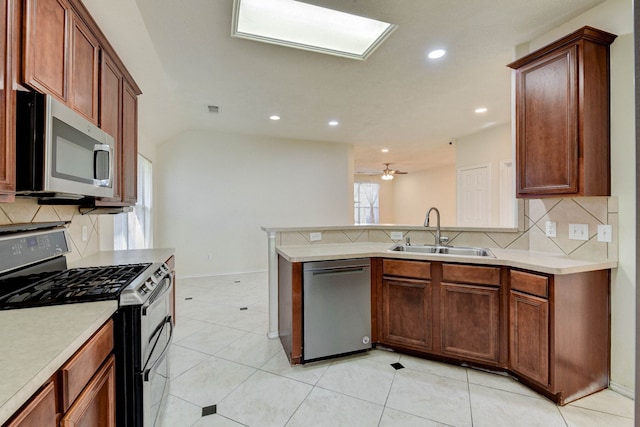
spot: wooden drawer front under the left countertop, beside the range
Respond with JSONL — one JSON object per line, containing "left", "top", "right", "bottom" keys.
{"left": 59, "top": 320, "right": 113, "bottom": 412}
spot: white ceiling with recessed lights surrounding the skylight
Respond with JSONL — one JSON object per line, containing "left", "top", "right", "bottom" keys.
{"left": 83, "top": 0, "right": 602, "bottom": 171}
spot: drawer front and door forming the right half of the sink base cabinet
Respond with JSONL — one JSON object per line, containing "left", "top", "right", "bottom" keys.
{"left": 440, "top": 264, "right": 500, "bottom": 364}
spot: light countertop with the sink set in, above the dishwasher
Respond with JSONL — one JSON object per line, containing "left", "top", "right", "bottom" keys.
{"left": 276, "top": 243, "right": 618, "bottom": 274}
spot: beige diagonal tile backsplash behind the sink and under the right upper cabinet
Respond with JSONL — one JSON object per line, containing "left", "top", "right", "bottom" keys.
{"left": 276, "top": 197, "right": 618, "bottom": 260}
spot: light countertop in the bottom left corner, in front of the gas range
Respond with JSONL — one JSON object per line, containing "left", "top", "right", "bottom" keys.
{"left": 0, "top": 301, "right": 118, "bottom": 423}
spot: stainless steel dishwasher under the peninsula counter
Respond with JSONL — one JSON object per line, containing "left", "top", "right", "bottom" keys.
{"left": 302, "top": 258, "right": 371, "bottom": 362}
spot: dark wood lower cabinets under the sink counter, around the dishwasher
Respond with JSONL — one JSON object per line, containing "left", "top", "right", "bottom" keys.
{"left": 278, "top": 257, "right": 610, "bottom": 405}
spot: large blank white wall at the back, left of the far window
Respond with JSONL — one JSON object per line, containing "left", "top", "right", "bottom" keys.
{"left": 154, "top": 131, "right": 353, "bottom": 277}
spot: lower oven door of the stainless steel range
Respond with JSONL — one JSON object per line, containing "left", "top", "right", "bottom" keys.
{"left": 141, "top": 316, "right": 173, "bottom": 426}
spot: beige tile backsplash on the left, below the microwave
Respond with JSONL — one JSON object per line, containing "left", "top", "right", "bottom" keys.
{"left": 0, "top": 198, "right": 100, "bottom": 262}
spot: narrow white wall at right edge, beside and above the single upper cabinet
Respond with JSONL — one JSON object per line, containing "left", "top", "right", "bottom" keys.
{"left": 530, "top": 0, "right": 636, "bottom": 395}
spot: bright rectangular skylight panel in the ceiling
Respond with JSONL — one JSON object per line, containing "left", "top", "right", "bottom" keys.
{"left": 232, "top": 0, "right": 397, "bottom": 59}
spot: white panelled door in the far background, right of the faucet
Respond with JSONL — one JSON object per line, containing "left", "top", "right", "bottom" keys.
{"left": 457, "top": 164, "right": 491, "bottom": 227}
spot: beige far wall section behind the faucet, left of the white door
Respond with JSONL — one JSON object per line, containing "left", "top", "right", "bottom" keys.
{"left": 393, "top": 165, "right": 456, "bottom": 226}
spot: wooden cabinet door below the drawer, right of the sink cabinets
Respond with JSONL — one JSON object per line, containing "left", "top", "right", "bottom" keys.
{"left": 509, "top": 291, "right": 549, "bottom": 387}
